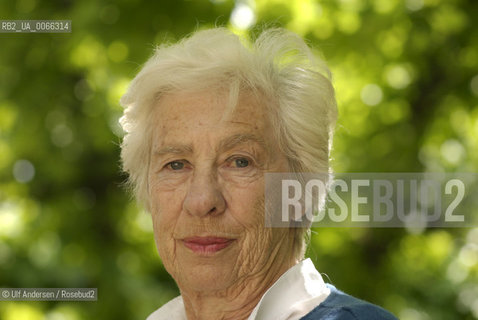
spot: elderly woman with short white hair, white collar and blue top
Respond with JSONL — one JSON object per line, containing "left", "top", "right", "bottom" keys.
{"left": 121, "top": 28, "right": 395, "bottom": 320}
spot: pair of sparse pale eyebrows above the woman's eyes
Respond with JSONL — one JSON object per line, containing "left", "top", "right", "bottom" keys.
{"left": 154, "top": 133, "right": 268, "bottom": 156}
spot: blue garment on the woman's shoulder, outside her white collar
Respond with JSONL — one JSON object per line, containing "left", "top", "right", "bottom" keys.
{"left": 301, "top": 284, "right": 398, "bottom": 320}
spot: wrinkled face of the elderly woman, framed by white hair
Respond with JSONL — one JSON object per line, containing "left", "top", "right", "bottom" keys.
{"left": 148, "top": 92, "right": 293, "bottom": 291}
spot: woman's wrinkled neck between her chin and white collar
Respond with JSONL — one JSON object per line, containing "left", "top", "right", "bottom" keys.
{"left": 181, "top": 254, "right": 297, "bottom": 320}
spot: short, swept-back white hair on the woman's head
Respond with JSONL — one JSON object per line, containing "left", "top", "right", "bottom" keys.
{"left": 120, "top": 28, "right": 337, "bottom": 258}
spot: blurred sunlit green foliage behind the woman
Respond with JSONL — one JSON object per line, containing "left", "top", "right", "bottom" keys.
{"left": 0, "top": 0, "right": 478, "bottom": 320}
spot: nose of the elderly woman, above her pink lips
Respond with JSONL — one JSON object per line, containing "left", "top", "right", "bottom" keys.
{"left": 183, "top": 170, "right": 226, "bottom": 217}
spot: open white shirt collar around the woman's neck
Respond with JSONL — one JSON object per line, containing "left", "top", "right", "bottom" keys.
{"left": 147, "top": 259, "right": 330, "bottom": 320}
